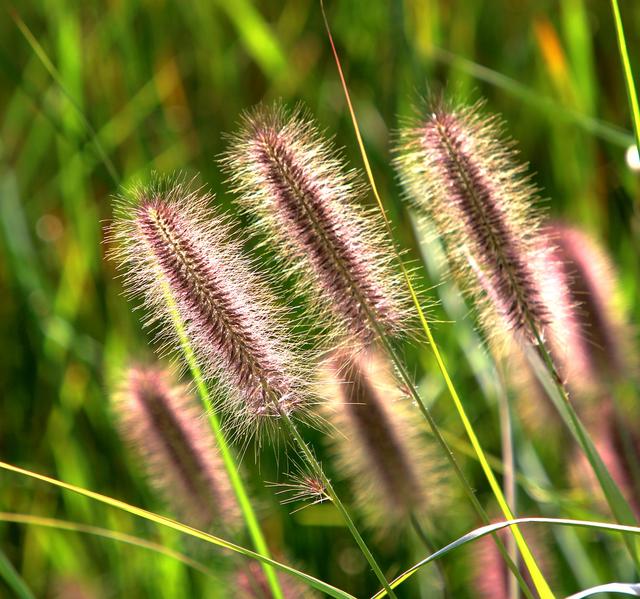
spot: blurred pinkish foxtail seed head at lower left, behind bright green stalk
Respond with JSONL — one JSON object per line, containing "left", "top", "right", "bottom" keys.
{"left": 114, "top": 368, "right": 240, "bottom": 530}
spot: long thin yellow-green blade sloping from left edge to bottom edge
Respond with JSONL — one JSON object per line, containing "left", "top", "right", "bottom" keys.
{"left": 0, "top": 461, "right": 356, "bottom": 599}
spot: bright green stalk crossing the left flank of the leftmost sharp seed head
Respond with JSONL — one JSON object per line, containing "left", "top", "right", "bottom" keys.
{"left": 162, "top": 280, "right": 284, "bottom": 599}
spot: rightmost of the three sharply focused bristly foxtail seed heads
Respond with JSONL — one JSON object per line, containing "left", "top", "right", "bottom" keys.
{"left": 395, "top": 102, "right": 548, "bottom": 340}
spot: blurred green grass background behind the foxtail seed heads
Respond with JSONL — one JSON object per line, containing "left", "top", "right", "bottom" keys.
{"left": 0, "top": 0, "right": 640, "bottom": 597}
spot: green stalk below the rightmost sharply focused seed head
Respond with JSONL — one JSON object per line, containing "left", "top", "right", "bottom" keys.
{"left": 528, "top": 322, "right": 640, "bottom": 572}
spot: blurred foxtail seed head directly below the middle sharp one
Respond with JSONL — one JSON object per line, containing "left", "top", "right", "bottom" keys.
{"left": 320, "top": 347, "right": 447, "bottom": 529}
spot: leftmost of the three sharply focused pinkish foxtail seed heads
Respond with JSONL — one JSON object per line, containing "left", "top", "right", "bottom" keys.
{"left": 112, "top": 182, "right": 304, "bottom": 431}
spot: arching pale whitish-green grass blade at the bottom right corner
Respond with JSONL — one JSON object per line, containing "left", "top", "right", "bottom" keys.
{"left": 372, "top": 518, "right": 640, "bottom": 599}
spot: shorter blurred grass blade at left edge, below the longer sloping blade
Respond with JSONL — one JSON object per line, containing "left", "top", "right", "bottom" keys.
{"left": 0, "top": 512, "right": 216, "bottom": 578}
